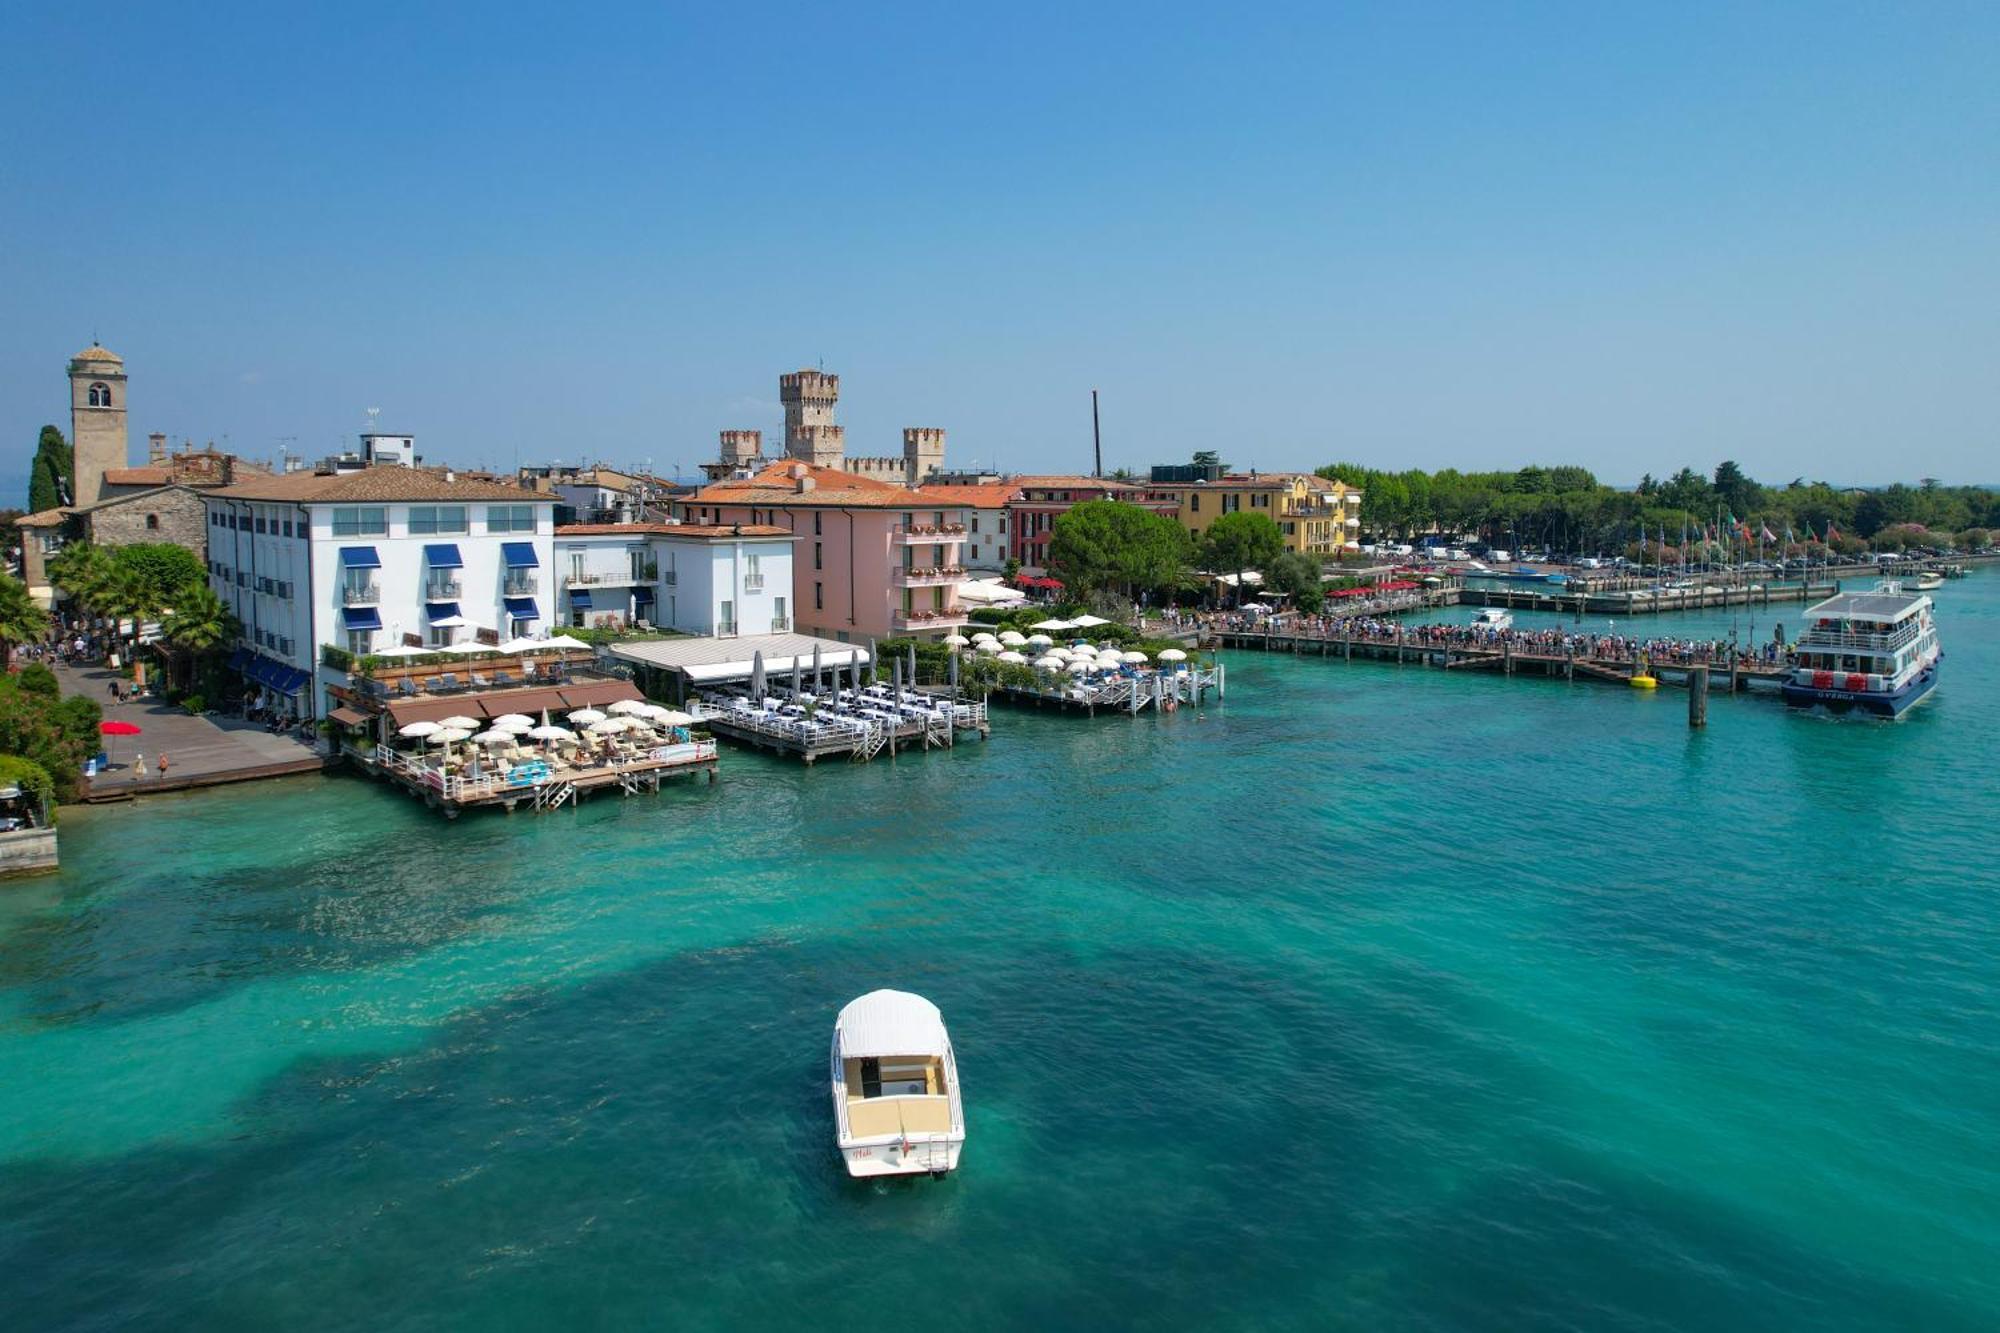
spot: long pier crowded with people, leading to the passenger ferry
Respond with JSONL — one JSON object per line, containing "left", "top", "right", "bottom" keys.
{"left": 1218, "top": 630, "right": 1790, "bottom": 693}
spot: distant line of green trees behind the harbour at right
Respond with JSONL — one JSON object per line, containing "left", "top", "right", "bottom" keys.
{"left": 1318, "top": 460, "right": 2000, "bottom": 550}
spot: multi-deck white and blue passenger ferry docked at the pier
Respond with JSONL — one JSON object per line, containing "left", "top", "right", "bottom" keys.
{"left": 1784, "top": 582, "right": 1944, "bottom": 717}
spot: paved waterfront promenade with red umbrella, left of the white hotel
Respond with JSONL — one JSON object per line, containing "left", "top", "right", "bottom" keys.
{"left": 52, "top": 664, "right": 326, "bottom": 801}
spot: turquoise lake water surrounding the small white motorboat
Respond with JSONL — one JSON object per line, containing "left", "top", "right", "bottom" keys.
{"left": 0, "top": 574, "right": 2000, "bottom": 1329}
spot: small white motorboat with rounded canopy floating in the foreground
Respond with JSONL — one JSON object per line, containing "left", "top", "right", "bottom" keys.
{"left": 832, "top": 991, "right": 966, "bottom": 1175}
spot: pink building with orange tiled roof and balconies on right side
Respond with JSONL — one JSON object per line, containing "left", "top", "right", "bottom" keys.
{"left": 676, "top": 458, "right": 966, "bottom": 642}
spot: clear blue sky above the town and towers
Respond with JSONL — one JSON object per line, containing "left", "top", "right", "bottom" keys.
{"left": 0, "top": 4, "right": 2000, "bottom": 494}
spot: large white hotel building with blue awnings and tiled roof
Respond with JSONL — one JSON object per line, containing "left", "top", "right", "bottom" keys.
{"left": 202, "top": 466, "right": 556, "bottom": 717}
